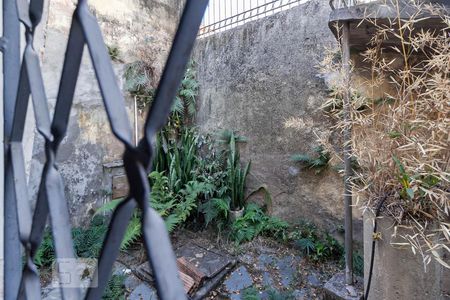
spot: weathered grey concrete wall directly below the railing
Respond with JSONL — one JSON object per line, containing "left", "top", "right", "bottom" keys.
{"left": 195, "top": 0, "right": 362, "bottom": 239}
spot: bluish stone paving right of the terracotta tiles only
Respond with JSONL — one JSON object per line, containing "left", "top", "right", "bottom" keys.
{"left": 175, "top": 231, "right": 339, "bottom": 300}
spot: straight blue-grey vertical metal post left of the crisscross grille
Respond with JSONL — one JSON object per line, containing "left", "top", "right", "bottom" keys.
{"left": 2, "top": 0, "right": 22, "bottom": 299}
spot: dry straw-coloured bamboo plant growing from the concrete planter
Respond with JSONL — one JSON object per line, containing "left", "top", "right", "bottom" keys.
{"left": 320, "top": 0, "right": 450, "bottom": 268}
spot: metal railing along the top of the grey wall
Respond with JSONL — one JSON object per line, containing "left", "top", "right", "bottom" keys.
{"left": 199, "top": 0, "right": 309, "bottom": 36}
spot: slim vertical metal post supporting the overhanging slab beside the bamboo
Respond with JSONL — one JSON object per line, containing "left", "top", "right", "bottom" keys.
{"left": 341, "top": 22, "right": 353, "bottom": 285}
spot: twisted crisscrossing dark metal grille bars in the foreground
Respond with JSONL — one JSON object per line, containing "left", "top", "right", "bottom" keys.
{"left": 5, "top": 0, "right": 208, "bottom": 299}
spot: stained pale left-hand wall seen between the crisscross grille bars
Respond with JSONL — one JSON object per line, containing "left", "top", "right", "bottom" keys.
{"left": 26, "top": 0, "right": 181, "bottom": 225}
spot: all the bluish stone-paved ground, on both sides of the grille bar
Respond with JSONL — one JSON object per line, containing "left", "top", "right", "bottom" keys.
{"left": 43, "top": 230, "right": 344, "bottom": 300}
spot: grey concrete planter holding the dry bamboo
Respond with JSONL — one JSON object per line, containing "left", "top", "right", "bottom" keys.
{"left": 364, "top": 213, "right": 450, "bottom": 300}
